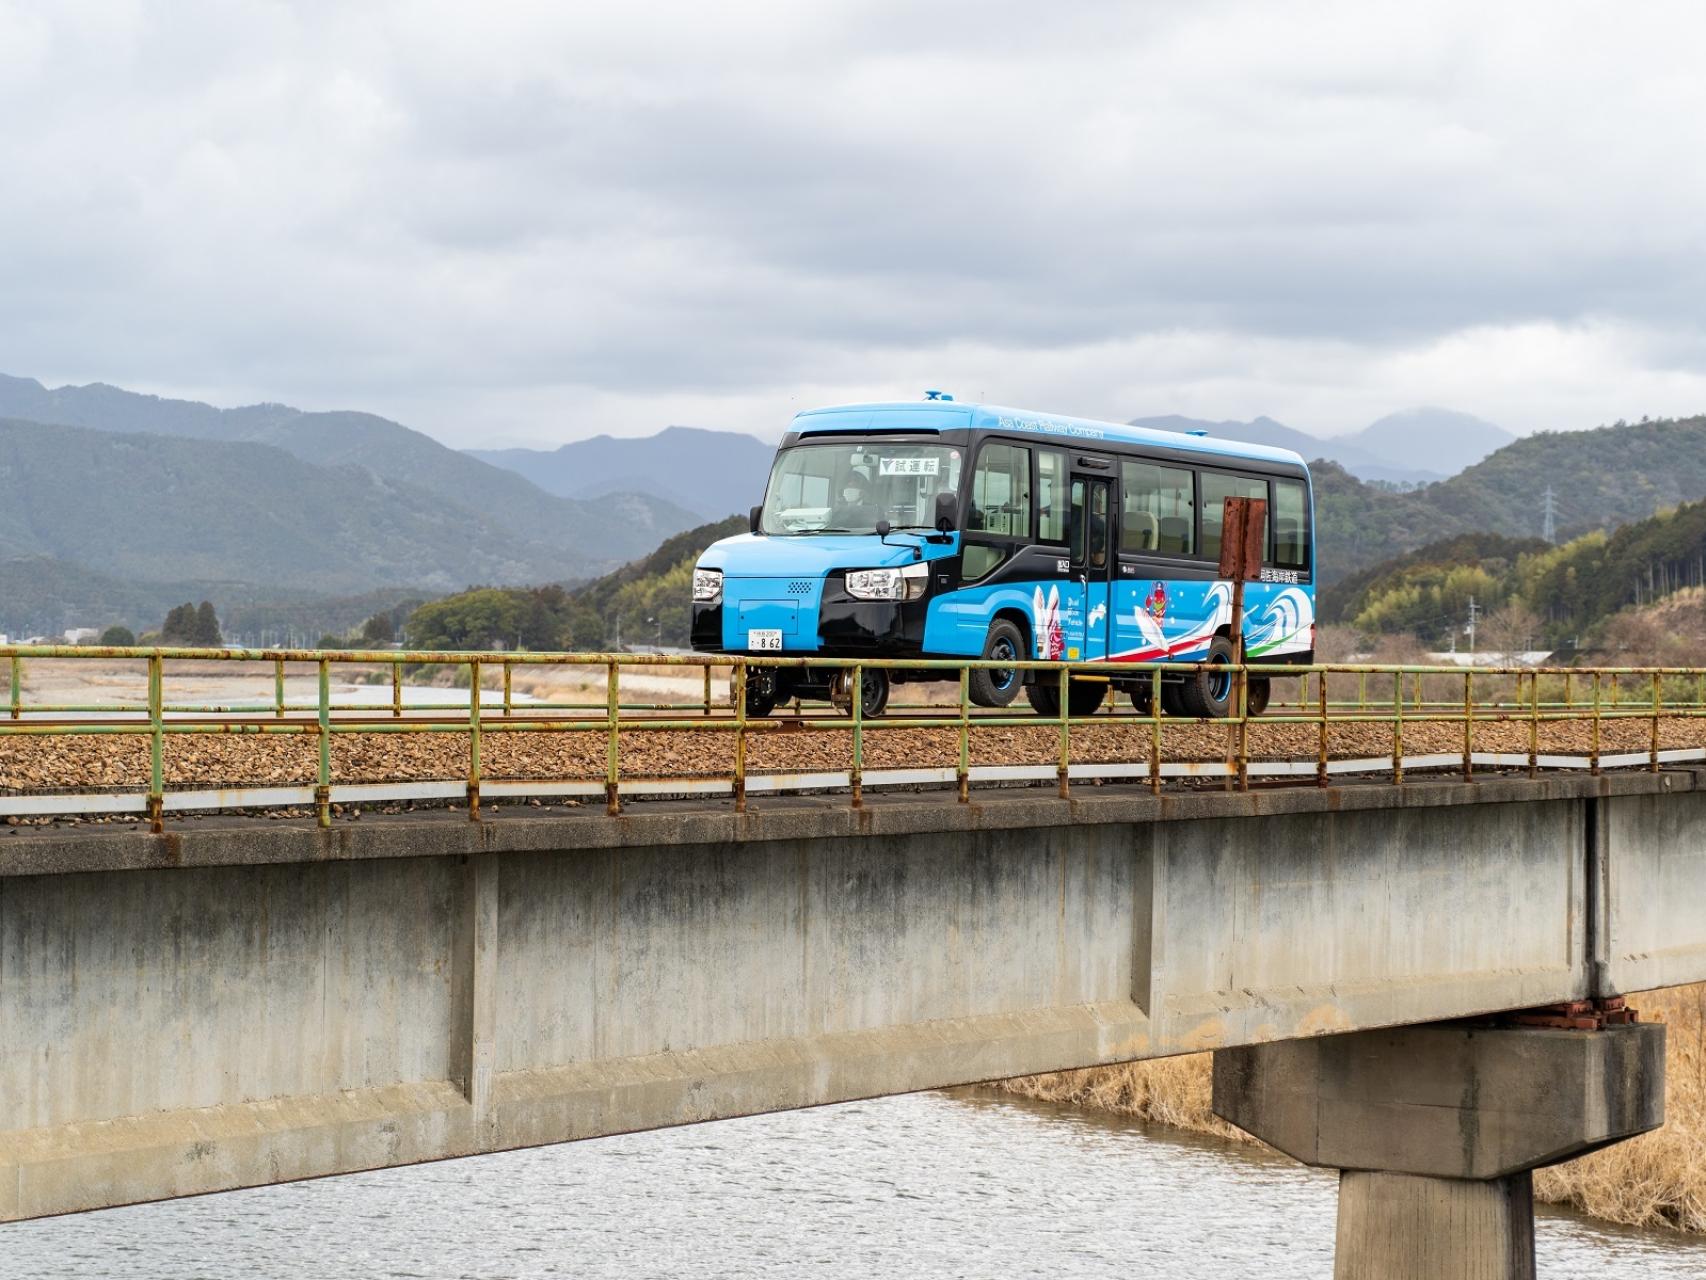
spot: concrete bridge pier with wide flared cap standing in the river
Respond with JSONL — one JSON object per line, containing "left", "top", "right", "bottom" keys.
{"left": 1215, "top": 1022, "right": 1665, "bottom": 1280}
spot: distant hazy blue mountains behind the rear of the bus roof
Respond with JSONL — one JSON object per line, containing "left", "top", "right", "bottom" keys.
{"left": 1131, "top": 406, "right": 1517, "bottom": 485}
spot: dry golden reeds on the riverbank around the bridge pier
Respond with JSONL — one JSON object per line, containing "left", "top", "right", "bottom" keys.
{"left": 1001, "top": 983, "right": 1706, "bottom": 1234}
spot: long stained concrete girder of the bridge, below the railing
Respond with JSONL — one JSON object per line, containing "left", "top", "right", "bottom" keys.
{"left": 0, "top": 770, "right": 1706, "bottom": 1220}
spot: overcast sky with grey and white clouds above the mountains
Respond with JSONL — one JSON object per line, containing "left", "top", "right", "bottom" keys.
{"left": 0, "top": 0, "right": 1706, "bottom": 445}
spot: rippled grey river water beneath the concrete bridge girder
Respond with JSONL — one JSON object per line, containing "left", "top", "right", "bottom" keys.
{"left": 0, "top": 1091, "right": 1706, "bottom": 1280}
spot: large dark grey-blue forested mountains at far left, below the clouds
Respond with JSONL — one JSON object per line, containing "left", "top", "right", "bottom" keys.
{"left": 0, "top": 375, "right": 727, "bottom": 631}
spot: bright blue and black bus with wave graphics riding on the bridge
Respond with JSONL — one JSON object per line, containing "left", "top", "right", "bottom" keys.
{"left": 693, "top": 391, "right": 1315, "bottom": 717}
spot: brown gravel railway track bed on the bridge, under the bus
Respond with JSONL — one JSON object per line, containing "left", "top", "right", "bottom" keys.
{"left": 0, "top": 650, "right": 1706, "bottom": 821}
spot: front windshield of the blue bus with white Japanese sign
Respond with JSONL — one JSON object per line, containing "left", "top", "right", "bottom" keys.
{"left": 759, "top": 440, "right": 960, "bottom": 534}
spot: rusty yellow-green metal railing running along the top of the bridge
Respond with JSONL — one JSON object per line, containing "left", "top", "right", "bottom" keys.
{"left": 0, "top": 647, "right": 1706, "bottom": 829}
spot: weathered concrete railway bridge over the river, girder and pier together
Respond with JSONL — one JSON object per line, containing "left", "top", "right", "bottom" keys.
{"left": 0, "top": 655, "right": 1706, "bottom": 1277}
